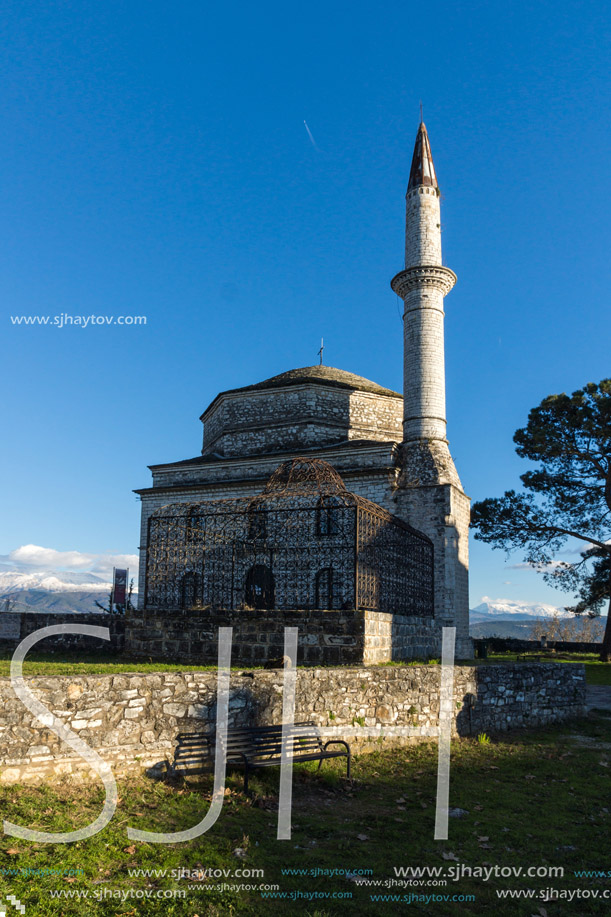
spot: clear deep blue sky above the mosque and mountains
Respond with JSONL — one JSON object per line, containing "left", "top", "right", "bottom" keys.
{"left": 0, "top": 0, "right": 611, "bottom": 604}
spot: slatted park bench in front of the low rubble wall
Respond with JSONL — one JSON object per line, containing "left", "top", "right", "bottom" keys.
{"left": 169, "top": 723, "right": 351, "bottom": 793}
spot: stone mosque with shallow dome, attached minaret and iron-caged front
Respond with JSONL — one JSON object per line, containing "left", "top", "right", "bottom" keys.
{"left": 127, "top": 123, "right": 472, "bottom": 664}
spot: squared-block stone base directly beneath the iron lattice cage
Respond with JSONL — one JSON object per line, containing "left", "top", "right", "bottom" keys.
{"left": 125, "top": 609, "right": 441, "bottom": 666}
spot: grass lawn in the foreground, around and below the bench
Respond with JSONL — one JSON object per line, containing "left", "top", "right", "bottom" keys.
{"left": 0, "top": 717, "right": 611, "bottom": 917}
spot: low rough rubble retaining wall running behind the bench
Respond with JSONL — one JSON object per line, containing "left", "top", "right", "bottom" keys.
{"left": 0, "top": 663, "right": 585, "bottom": 783}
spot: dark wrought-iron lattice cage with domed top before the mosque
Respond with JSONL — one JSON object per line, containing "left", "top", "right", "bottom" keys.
{"left": 145, "top": 458, "right": 433, "bottom": 616}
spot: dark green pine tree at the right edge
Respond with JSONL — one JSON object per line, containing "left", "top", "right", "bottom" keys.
{"left": 471, "top": 379, "right": 611, "bottom": 660}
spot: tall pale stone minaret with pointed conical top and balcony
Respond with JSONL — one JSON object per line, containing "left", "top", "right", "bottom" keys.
{"left": 391, "top": 122, "right": 472, "bottom": 656}
